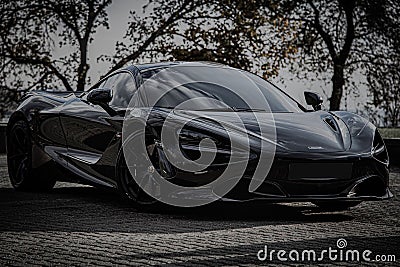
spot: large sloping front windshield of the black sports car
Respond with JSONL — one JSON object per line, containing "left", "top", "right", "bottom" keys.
{"left": 138, "top": 66, "right": 304, "bottom": 113}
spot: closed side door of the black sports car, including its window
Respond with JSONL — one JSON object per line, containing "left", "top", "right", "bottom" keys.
{"left": 60, "top": 72, "right": 136, "bottom": 186}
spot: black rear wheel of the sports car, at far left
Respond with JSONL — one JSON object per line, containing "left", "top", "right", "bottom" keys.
{"left": 7, "top": 120, "right": 56, "bottom": 191}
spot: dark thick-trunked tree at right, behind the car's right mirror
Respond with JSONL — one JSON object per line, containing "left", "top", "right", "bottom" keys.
{"left": 263, "top": 0, "right": 399, "bottom": 110}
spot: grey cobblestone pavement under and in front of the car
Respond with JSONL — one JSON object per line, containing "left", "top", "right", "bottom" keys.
{"left": 0, "top": 156, "right": 400, "bottom": 266}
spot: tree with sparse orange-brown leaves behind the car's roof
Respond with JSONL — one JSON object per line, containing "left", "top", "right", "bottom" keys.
{"left": 106, "top": 0, "right": 297, "bottom": 75}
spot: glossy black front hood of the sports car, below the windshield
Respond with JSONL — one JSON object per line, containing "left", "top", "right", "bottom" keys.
{"left": 174, "top": 110, "right": 351, "bottom": 153}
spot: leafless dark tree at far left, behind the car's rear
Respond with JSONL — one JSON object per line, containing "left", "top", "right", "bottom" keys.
{"left": 0, "top": 0, "right": 111, "bottom": 94}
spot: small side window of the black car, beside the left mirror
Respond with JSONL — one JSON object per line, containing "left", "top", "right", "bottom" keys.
{"left": 104, "top": 72, "right": 136, "bottom": 108}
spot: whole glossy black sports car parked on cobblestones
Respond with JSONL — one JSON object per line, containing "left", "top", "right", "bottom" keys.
{"left": 7, "top": 62, "right": 392, "bottom": 209}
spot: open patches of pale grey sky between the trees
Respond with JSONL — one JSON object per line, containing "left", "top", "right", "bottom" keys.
{"left": 55, "top": 0, "right": 366, "bottom": 110}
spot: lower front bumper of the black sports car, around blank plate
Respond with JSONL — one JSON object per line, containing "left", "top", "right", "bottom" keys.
{"left": 166, "top": 157, "right": 393, "bottom": 202}
